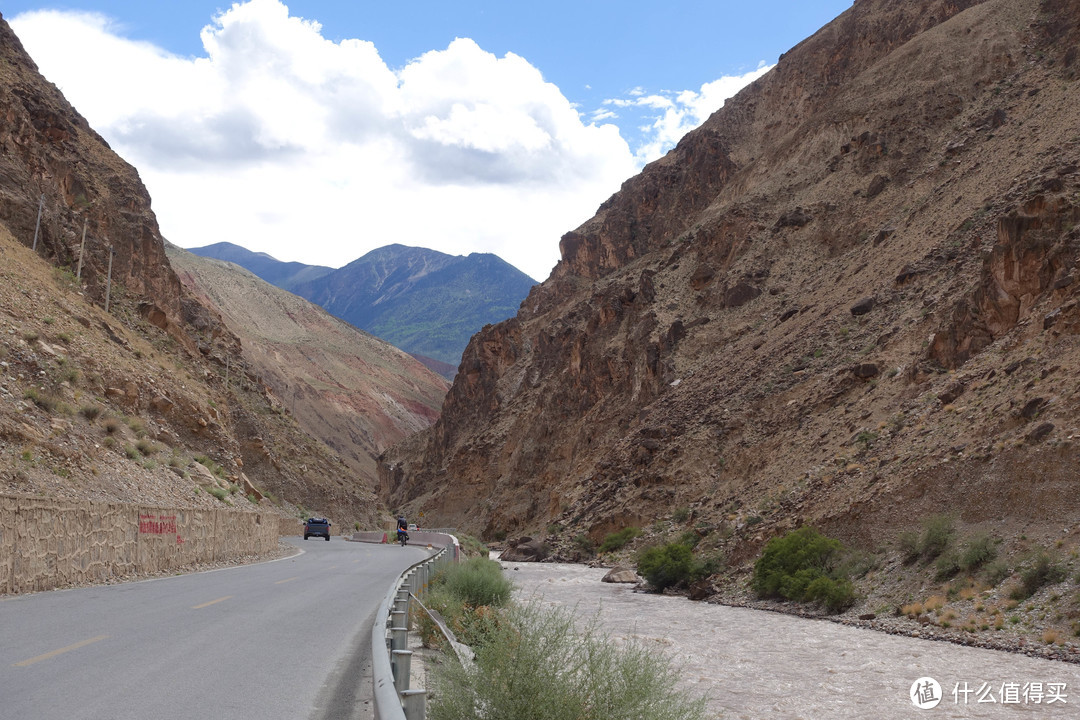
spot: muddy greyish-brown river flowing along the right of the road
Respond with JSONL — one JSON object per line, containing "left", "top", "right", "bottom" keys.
{"left": 502, "top": 562, "right": 1080, "bottom": 720}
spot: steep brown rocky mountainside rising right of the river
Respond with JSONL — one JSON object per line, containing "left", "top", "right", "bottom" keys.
{"left": 379, "top": 0, "right": 1080, "bottom": 558}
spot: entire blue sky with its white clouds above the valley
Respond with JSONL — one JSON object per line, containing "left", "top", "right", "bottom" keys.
{"left": 3, "top": 0, "right": 850, "bottom": 280}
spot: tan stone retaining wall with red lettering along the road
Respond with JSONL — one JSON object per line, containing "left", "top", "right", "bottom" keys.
{"left": 0, "top": 495, "right": 280, "bottom": 593}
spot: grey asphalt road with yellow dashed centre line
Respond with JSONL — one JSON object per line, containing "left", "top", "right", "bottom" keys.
{"left": 0, "top": 538, "right": 427, "bottom": 720}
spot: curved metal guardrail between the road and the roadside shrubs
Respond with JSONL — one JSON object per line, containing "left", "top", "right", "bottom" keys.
{"left": 372, "top": 533, "right": 460, "bottom": 720}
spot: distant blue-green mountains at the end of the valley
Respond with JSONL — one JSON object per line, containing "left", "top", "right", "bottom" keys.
{"left": 191, "top": 243, "right": 535, "bottom": 378}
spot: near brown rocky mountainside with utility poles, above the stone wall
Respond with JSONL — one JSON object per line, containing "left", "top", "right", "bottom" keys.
{"left": 0, "top": 12, "right": 429, "bottom": 525}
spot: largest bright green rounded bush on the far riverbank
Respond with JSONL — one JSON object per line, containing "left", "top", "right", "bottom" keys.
{"left": 753, "top": 528, "right": 855, "bottom": 611}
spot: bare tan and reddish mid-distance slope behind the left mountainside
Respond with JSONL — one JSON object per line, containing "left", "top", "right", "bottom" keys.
{"left": 166, "top": 245, "right": 448, "bottom": 485}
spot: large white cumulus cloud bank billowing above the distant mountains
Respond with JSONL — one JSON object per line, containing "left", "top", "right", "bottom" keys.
{"left": 12, "top": 0, "right": 637, "bottom": 280}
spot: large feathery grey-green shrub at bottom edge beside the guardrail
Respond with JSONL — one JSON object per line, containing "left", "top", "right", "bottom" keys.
{"left": 428, "top": 604, "right": 704, "bottom": 720}
